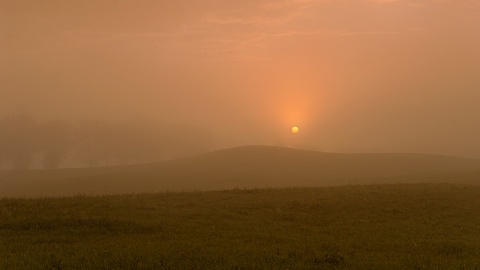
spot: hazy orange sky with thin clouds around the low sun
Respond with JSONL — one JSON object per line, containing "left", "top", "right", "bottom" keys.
{"left": 0, "top": 0, "right": 480, "bottom": 158}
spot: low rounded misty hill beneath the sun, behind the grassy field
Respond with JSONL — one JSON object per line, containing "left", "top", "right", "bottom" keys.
{"left": 0, "top": 146, "right": 480, "bottom": 197}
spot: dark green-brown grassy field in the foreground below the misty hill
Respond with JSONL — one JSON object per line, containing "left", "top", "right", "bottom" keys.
{"left": 0, "top": 184, "right": 480, "bottom": 269}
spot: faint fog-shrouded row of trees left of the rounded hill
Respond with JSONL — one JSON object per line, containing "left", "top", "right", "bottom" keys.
{"left": 0, "top": 115, "right": 213, "bottom": 170}
